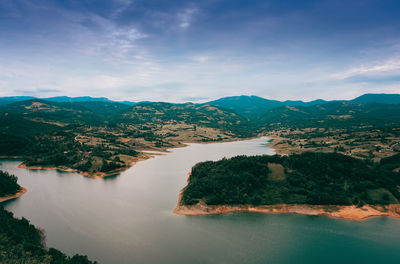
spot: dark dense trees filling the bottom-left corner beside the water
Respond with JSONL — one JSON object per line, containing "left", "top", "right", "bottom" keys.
{"left": 0, "top": 206, "right": 96, "bottom": 264}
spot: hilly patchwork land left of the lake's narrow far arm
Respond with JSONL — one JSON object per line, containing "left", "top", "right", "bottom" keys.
{"left": 0, "top": 99, "right": 250, "bottom": 177}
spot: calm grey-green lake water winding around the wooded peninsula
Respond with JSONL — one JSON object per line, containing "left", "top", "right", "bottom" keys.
{"left": 0, "top": 139, "right": 400, "bottom": 264}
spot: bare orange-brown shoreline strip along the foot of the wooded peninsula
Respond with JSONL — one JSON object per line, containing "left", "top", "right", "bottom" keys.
{"left": 173, "top": 190, "right": 400, "bottom": 221}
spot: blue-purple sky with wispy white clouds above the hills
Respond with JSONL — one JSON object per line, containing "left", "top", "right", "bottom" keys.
{"left": 0, "top": 0, "right": 400, "bottom": 102}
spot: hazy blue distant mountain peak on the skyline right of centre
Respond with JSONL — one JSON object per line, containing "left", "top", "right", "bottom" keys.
{"left": 206, "top": 95, "right": 327, "bottom": 117}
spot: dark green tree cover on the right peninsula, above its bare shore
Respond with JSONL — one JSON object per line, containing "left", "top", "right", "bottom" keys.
{"left": 182, "top": 152, "right": 400, "bottom": 205}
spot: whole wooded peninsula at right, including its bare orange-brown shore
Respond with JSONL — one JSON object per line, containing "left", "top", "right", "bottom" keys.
{"left": 174, "top": 152, "right": 400, "bottom": 220}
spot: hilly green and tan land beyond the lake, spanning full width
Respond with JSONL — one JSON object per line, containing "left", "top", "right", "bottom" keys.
{"left": 0, "top": 95, "right": 400, "bottom": 178}
